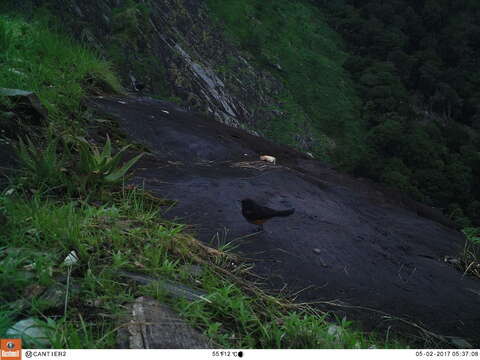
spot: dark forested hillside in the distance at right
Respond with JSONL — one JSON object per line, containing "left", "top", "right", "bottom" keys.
{"left": 314, "top": 0, "right": 480, "bottom": 225}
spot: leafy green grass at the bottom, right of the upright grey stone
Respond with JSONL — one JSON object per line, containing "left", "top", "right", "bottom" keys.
{"left": 172, "top": 272, "right": 405, "bottom": 349}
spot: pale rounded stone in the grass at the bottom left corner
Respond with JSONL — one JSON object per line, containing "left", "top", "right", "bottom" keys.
{"left": 5, "top": 318, "right": 50, "bottom": 347}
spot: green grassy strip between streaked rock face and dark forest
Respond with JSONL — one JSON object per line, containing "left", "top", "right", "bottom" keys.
{"left": 208, "top": 0, "right": 362, "bottom": 162}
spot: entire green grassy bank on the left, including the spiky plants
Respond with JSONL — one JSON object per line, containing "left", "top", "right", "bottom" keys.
{"left": 0, "top": 17, "right": 404, "bottom": 348}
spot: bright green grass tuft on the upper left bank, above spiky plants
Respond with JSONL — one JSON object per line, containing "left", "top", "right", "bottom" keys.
{"left": 0, "top": 16, "right": 121, "bottom": 129}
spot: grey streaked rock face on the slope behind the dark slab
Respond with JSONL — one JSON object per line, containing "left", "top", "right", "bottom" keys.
{"left": 22, "top": 0, "right": 282, "bottom": 128}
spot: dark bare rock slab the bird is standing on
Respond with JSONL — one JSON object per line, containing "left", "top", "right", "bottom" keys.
{"left": 90, "top": 97, "right": 480, "bottom": 346}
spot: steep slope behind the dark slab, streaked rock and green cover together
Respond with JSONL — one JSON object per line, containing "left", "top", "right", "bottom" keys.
{"left": 2, "top": 0, "right": 362, "bottom": 160}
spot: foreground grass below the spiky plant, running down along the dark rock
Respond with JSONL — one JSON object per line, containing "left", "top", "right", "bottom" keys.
{"left": 0, "top": 189, "right": 404, "bottom": 348}
